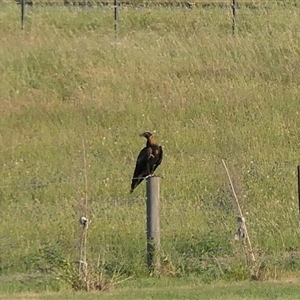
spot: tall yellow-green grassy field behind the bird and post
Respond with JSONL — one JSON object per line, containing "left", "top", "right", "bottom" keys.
{"left": 0, "top": 2, "right": 300, "bottom": 293}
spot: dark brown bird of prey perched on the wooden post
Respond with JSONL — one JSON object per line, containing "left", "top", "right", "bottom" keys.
{"left": 130, "top": 132, "right": 163, "bottom": 193}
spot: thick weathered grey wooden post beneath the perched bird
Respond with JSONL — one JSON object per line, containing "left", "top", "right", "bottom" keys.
{"left": 146, "top": 176, "right": 160, "bottom": 273}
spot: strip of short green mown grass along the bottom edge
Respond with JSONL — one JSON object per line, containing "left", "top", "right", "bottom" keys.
{"left": 0, "top": 278, "right": 300, "bottom": 300}
